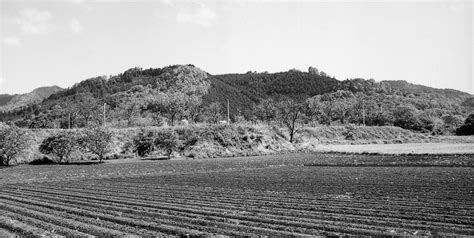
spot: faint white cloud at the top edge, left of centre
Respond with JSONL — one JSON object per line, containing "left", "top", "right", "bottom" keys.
{"left": 176, "top": 2, "right": 217, "bottom": 27}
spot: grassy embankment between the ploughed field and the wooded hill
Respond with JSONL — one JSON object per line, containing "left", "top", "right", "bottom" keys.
{"left": 10, "top": 124, "right": 462, "bottom": 163}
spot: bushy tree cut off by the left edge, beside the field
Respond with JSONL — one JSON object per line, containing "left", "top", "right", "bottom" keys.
{"left": 0, "top": 127, "right": 30, "bottom": 166}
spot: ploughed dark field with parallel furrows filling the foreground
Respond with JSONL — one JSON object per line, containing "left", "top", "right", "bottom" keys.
{"left": 0, "top": 154, "right": 474, "bottom": 236}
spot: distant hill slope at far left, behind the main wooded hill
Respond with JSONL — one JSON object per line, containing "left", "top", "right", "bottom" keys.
{"left": 0, "top": 86, "right": 63, "bottom": 111}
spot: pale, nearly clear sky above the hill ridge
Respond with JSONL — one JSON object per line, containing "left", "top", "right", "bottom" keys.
{"left": 0, "top": 0, "right": 474, "bottom": 94}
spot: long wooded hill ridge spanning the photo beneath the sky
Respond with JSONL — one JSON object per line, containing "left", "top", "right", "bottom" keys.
{"left": 0, "top": 65, "right": 474, "bottom": 128}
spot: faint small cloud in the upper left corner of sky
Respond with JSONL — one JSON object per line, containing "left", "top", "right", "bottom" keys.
{"left": 16, "top": 8, "right": 52, "bottom": 34}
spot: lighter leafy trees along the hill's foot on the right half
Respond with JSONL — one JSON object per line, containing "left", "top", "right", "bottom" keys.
{"left": 254, "top": 90, "right": 466, "bottom": 138}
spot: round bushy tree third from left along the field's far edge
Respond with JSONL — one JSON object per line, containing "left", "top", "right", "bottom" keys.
{"left": 80, "top": 127, "right": 112, "bottom": 162}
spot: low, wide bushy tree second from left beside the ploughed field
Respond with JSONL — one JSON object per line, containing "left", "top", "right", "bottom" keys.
{"left": 39, "top": 132, "right": 77, "bottom": 163}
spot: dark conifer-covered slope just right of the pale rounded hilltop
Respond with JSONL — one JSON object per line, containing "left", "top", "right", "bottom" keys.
{"left": 204, "top": 71, "right": 339, "bottom": 115}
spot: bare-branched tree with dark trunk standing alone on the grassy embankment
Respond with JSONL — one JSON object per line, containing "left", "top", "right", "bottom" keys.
{"left": 277, "top": 99, "right": 303, "bottom": 143}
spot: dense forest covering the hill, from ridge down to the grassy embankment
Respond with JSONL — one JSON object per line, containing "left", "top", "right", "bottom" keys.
{"left": 0, "top": 65, "right": 474, "bottom": 134}
